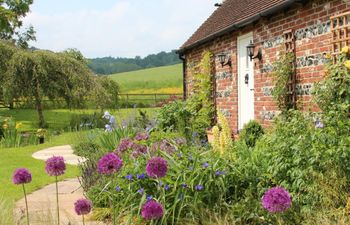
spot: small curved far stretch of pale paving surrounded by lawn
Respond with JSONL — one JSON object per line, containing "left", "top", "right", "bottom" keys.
{"left": 32, "top": 145, "right": 85, "bottom": 165}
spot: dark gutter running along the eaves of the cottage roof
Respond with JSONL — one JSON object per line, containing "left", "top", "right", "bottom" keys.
{"left": 176, "top": 0, "right": 298, "bottom": 55}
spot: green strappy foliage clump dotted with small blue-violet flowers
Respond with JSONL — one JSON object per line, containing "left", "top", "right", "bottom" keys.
{"left": 88, "top": 131, "right": 230, "bottom": 224}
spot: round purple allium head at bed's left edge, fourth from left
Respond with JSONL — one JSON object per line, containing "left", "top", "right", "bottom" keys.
{"left": 97, "top": 153, "right": 123, "bottom": 175}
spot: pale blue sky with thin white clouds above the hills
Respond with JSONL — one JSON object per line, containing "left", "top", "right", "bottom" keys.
{"left": 24, "top": 0, "right": 220, "bottom": 58}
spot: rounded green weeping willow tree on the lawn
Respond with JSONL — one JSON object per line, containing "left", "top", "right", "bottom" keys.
{"left": 4, "top": 49, "right": 94, "bottom": 127}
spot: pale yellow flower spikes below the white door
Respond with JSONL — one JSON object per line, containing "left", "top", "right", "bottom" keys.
{"left": 212, "top": 111, "right": 233, "bottom": 155}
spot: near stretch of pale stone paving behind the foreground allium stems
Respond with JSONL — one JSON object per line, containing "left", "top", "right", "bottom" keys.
{"left": 16, "top": 178, "right": 103, "bottom": 225}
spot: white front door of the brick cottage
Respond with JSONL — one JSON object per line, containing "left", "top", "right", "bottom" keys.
{"left": 237, "top": 33, "right": 254, "bottom": 129}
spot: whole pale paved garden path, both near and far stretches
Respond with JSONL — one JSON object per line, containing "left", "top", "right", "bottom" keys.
{"left": 16, "top": 145, "right": 103, "bottom": 225}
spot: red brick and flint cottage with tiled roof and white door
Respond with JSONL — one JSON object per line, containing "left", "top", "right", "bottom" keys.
{"left": 178, "top": 0, "right": 350, "bottom": 131}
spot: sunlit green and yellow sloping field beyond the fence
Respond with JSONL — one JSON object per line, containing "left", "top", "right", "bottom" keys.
{"left": 109, "top": 64, "right": 182, "bottom": 94}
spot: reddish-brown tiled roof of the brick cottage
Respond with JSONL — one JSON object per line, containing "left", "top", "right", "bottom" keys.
{"left": 180, "top": 0, "right": 296, "bottom": 51}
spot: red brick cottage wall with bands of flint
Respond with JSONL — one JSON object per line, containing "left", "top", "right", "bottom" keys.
{"left": 185, "top": 0, "right": 350, "bottom": 134}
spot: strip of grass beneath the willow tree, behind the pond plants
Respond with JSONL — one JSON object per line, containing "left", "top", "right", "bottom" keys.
{"left": 0, "top": 108, "right": 156, "bottom": 131}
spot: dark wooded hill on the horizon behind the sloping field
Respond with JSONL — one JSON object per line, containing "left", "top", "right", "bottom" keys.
{"left": 88, "top": 50, "right": 180, "bottom": 74}
